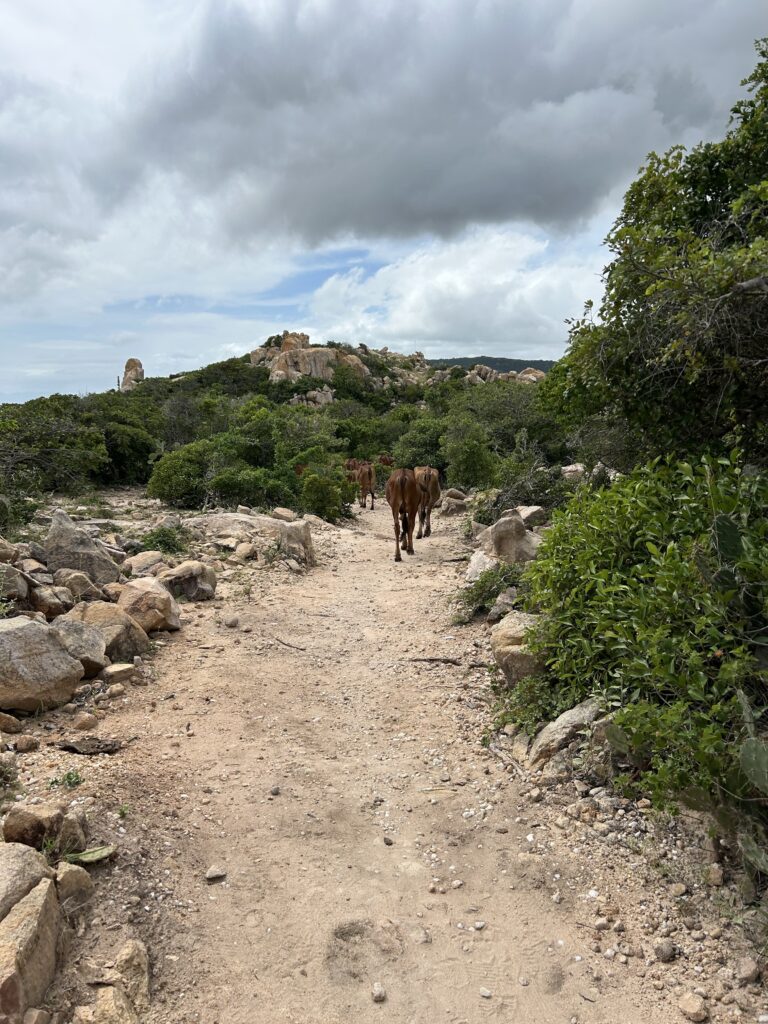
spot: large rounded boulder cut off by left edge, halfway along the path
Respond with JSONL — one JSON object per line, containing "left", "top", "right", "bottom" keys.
{"left": 0, "top": 615, "right": 83, "bottom": 712}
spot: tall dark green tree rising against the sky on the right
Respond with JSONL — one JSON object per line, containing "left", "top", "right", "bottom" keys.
{"left": 542, "top": 39, "right": 768, "bottom": 463}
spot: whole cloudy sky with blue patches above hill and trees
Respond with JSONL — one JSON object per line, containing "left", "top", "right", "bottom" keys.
{"left": 0, "top": 0, "right": 768, "bottom": 400}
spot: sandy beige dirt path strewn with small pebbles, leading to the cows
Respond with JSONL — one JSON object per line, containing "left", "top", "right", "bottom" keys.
{"left": 93, "top": 504, "right": 678, "bottom": 1024}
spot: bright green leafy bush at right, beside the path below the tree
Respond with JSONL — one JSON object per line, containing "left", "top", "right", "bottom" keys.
{"left": 527, "top": 457, "right": 768, "bottom": 804}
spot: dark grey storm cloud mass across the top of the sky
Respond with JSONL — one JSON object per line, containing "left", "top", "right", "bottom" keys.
{"left": 116, "top": 0, "right": 765, "bottom": 243}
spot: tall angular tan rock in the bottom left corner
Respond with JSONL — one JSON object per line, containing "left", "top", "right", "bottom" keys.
{"left": 0, "top": 879, "right": 61, "bottom": 1024}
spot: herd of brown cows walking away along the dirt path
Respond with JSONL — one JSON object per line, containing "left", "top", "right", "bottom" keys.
{"left": 344, "top": 455, "right": 440, "bottom": 562}
